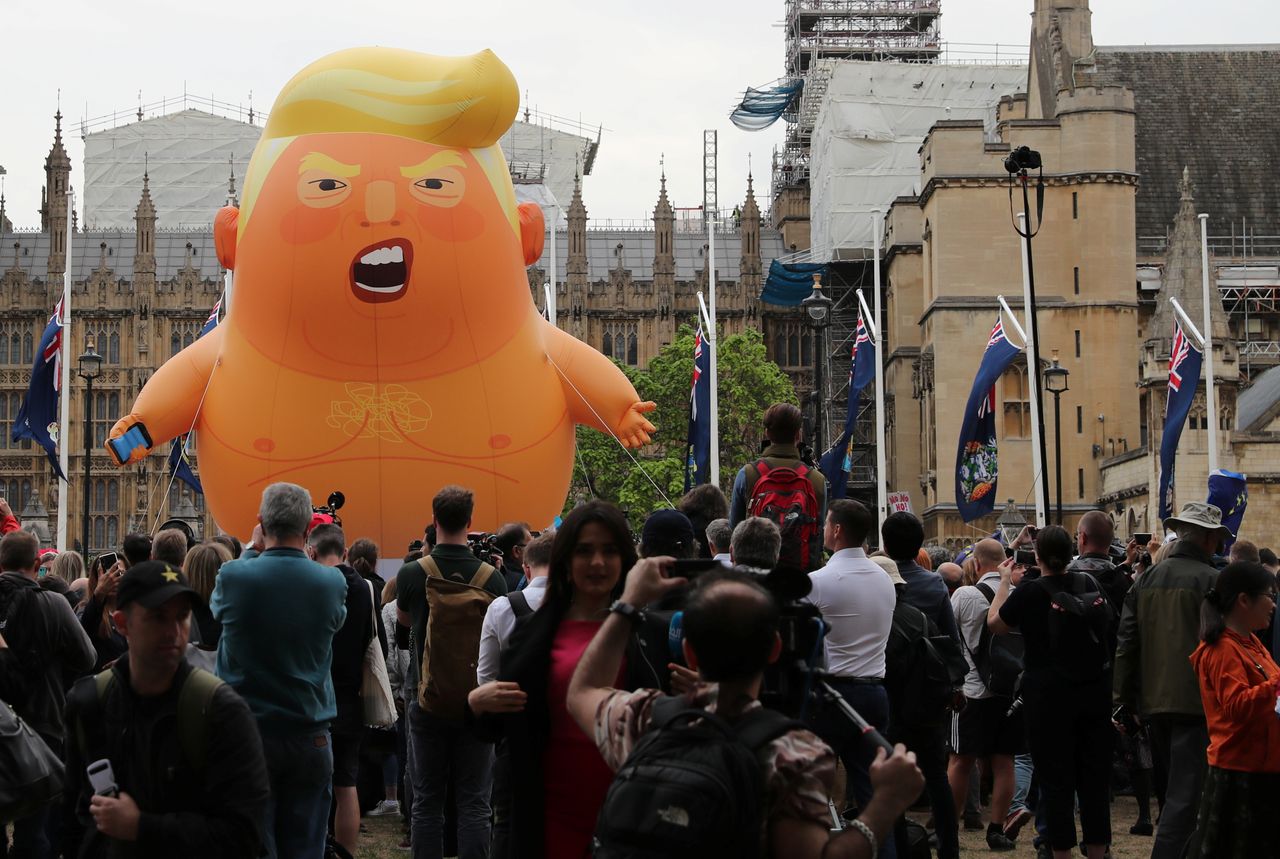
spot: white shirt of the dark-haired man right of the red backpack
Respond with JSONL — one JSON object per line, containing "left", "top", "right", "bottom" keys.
{"left": 809, "top": 549, "right": 897, "bottom": 678}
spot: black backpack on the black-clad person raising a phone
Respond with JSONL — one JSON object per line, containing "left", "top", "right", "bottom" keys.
{"left": 1039, "top": 572, "right": 1115, "bottom": 684}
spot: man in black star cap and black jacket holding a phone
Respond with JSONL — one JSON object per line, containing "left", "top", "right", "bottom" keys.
{"left": 63, "top": 561, "right": 269, "bottom": 858}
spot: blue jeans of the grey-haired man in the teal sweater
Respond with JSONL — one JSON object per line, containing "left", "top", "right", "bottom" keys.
{"left": 262, "top": 730, "right": 333, "bottom": 859}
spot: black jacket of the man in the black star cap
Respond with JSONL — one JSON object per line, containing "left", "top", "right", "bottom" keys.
{"left": 63, "top": 659, "right": 270, "bottom": 859}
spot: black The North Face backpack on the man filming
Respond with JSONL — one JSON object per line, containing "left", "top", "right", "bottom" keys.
{"left": 593, "top": 698, "right": 804, "bottom": 859}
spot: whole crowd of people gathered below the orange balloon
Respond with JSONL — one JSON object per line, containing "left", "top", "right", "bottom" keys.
{"left": 0, "top": 403, "right": 1280, "bottom": 859}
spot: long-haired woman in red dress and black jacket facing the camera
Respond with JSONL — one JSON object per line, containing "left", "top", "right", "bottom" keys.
{"left": 468, "top": 502, "right": 666, "bottom": 859}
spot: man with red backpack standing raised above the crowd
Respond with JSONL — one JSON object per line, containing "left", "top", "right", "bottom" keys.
{"left": 730, "top": 403, "right": 827, "bottom": 572}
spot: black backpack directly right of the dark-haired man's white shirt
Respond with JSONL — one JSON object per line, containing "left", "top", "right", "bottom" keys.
{"left": 884, "top": 595, "right": 969, "bottom": 727}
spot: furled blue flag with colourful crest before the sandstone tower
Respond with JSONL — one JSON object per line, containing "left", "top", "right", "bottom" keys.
{"left": 956, "top": 317, "right": 1020, "bottom": 522}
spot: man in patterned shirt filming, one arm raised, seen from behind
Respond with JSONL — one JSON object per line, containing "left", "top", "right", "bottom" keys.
{"left": 566, "top": 558, "right": 923, "bottom": 859}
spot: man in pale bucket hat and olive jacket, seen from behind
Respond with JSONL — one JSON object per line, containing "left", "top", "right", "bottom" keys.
{"left": 1114, "top": 502, "right": 1231, "bottom": 859}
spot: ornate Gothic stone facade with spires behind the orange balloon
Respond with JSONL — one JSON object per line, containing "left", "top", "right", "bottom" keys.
{"left": 0, "top": 114, "right": 798, "bottom": 554}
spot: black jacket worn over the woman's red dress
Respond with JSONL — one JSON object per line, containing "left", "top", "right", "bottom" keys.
{"left": 467, "top": 604, "right": 669, "bottom": 859}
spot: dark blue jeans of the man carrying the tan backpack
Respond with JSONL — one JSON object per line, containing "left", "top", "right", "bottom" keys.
{"left": 408, "top": 702, "right": 493, "bottom": 859}
